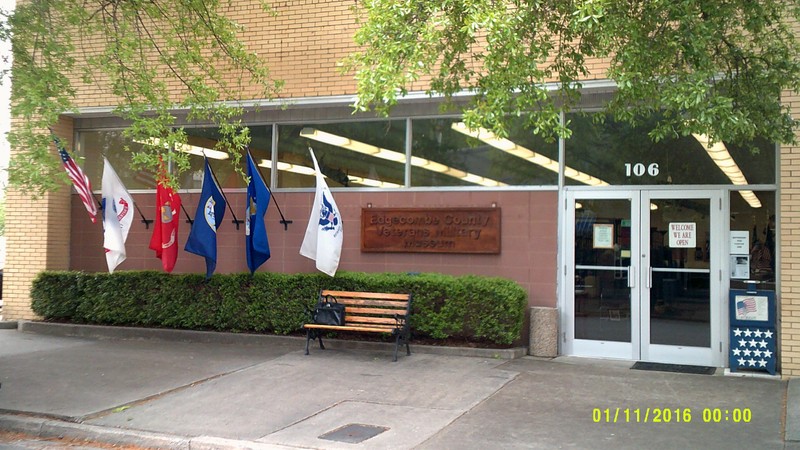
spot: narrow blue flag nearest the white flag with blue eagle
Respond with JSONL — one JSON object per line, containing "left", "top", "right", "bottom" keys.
{"left": 244, "top": 152, "right": 270, "bottom": 274}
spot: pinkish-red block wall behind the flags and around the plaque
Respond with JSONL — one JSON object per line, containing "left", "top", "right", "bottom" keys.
{"left": 70, "top": 191, "right": 558, "bottom": 307}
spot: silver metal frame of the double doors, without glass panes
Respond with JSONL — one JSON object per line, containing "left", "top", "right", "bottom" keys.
{"left": 559, "top": 188, "right": 727, "bottom": 367}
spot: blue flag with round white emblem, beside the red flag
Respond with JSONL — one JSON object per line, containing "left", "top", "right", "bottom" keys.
{"left": 184, "top": 158, "right": 225, "bottom": 278}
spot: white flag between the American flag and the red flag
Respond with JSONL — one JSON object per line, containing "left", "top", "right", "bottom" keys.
{"left": 102, "top": 158, "right": 134, "bottom": 273}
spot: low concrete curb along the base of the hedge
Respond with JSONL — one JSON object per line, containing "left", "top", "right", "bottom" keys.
{"left": 15, "top": 321, "right": 528, "bottom": 360}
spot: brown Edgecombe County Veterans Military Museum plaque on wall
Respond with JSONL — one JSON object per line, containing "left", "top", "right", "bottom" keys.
{"left": 361, "top": 208, "right": 500, "bottom": 253}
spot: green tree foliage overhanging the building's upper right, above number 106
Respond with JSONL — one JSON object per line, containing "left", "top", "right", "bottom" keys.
{"left": 346, "top": 0, "right": 800, "bottom": 143}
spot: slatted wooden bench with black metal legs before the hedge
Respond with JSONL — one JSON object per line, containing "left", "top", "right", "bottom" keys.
{"left": 303, "top": 290, "right": 411, "bottom": 361}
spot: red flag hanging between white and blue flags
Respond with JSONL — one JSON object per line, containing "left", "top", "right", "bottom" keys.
{"left": 150, "top": 162, "right": 181, "bottom": 272}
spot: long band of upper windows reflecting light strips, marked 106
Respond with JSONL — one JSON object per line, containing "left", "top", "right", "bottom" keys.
{"left": 77, "top": 113, "right": 776, "bottom": 190}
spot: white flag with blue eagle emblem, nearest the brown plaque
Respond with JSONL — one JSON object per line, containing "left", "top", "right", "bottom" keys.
{"left": 300, "top": 147, "right": 344, "bottom": 276}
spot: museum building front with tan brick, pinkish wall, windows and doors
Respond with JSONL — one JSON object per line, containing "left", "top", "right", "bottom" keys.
{"left": 3, "top": 1, "right": 800, "bottom": 377}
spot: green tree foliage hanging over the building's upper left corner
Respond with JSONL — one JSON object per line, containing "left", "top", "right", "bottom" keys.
{"left": 0, "top": 0, "right": 281, "bottom": 194}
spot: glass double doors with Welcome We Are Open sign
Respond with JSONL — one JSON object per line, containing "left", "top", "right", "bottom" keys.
{"left": 564, "top": 190, "right": 723, "bottom": 366}
